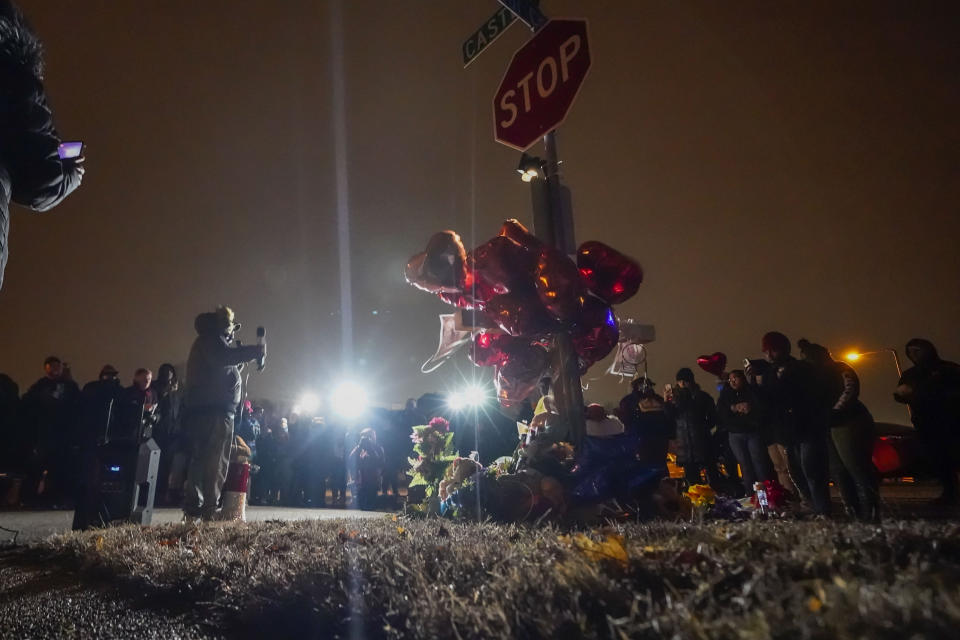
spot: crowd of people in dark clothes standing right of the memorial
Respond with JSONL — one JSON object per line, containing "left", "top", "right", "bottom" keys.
{"left": 618, "top": 331, "right": 960, "bottom": 521}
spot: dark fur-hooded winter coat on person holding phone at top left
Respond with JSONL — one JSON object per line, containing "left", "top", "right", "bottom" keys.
{"left": 0, "top": 1, "right": 80, "bottom": 286}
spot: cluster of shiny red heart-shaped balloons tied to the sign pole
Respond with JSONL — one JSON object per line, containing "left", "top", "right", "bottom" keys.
{"left": 406, "top": 220, "right": 643, "bottom": 405}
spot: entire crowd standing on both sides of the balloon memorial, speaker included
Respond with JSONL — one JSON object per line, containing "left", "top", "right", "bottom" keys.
{"left": 0, "top": 330, "right": 960, "bottom": 520}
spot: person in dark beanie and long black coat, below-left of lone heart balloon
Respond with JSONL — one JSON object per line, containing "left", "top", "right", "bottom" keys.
{"left": 667, "top": 367, "right": 722, "bottom": 488}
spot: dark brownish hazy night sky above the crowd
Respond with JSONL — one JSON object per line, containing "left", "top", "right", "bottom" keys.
{"left": 0, "top": 0, "right": 960, "bottom": 421}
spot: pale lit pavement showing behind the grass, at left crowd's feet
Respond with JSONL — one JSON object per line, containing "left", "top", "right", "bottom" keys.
{"left": 0, "top": 507, "right": 383, "bottom": 543}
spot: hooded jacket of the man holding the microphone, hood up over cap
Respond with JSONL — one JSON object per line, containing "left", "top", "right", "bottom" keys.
{"left": 184, "top": 313, "right": 259, "bottom": 416}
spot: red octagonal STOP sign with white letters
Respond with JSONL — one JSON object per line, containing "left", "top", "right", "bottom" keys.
{"left": 493, "top": 20, "right": 590, "bottom": 151}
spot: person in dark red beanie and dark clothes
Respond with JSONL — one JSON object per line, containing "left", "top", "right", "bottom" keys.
{"left": 760, "top": 331, "right": 831, "bottom": 516}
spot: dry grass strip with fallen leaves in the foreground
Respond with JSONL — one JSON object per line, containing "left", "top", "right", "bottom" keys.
{"left": 33, "top": 518, "right": 960, "bottom": 639}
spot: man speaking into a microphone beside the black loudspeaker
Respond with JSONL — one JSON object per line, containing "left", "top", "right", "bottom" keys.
{"left": 183, "top": 307, "right": 266, "bottom": 520}
